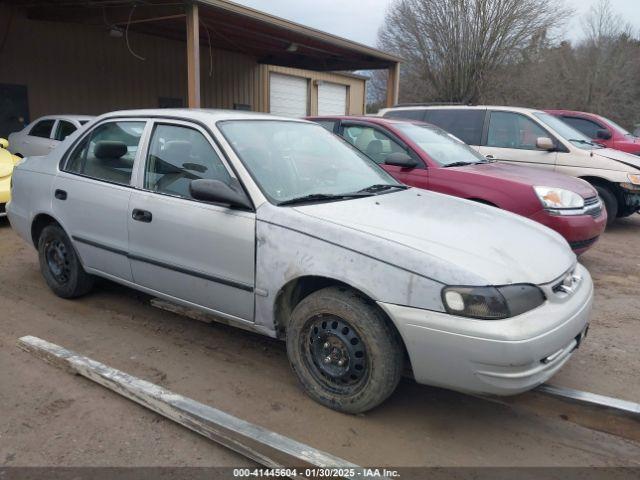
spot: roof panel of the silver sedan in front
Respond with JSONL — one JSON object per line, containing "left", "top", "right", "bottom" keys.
{"left": 99, "top": 108, "right": 306, "bottom": 123}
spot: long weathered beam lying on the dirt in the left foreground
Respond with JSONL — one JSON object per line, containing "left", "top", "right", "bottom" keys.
{"left": 18, "top": 336, "right": 372, "bottom": 479}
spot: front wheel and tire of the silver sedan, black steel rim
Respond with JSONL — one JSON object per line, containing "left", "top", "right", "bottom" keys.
{"left": 287, "top": 287, "right": 404, "bottom": 413}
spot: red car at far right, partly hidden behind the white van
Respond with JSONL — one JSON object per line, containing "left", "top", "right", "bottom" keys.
{"left": 546, "top": 110, "right": 640, "bottom": 155}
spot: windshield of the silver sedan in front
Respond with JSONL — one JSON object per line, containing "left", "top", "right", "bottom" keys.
{"left": 217, "top": 120, "right": 406, "bottom": 204}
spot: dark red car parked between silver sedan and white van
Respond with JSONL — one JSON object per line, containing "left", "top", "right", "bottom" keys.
{"left": 308, "top": 116, "right": 607, "bottom": 254}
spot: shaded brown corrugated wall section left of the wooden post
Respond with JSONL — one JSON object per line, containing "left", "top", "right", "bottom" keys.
{"left": 0, "top": 8, "right": 186, "bottom": 118}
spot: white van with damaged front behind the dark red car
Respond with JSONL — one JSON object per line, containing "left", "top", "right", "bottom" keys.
{"left": 378, "top": 105, "right": 640, "bottom": 223}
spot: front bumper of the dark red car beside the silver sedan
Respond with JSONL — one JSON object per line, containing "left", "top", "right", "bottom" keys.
{"left": 530, "top": 208, "right": 607, "bottom": 255}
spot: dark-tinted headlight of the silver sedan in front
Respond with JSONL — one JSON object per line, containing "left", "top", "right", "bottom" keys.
{"left": 442, "top": 283, "right": 546, "bottom": 320}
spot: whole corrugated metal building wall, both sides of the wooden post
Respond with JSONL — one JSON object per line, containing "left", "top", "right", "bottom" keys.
{"left": 0, "top": 5, "right": 365, "bottom": 119}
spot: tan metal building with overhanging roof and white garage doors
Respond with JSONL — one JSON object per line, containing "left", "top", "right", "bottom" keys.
{"left": 0, "top": 0, "right": 400, "bottom": 136}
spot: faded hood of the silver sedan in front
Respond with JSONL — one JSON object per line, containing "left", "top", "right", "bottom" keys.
{"left": 259, "top": 188, "right": 576, "bottom": 285}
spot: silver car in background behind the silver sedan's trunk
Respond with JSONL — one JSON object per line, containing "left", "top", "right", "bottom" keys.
{"left": 9, "top": 115, "right": 94, "bottom": 157}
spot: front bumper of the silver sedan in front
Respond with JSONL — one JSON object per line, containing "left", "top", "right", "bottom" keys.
{"left": 379, "top": 265, "right": 593, "bottom": 395}
